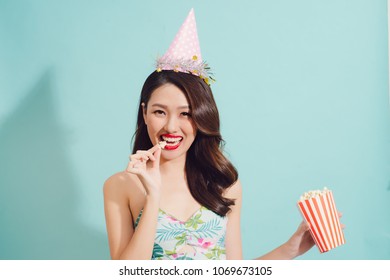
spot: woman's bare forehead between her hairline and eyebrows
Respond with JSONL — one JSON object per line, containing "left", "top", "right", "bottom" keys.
{"left": 149, "top": 84, "right": 189, "bottom": 106}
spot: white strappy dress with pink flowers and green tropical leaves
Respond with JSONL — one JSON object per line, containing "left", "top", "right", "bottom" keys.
{"left": 135, "top": 206, "right": 227, "bottom": 260}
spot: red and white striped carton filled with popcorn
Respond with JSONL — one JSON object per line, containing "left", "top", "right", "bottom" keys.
{"left": 298, "top": 188, "right": 345, "bottom": 253}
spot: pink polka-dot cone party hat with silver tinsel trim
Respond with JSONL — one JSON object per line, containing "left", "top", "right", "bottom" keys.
{"left": 156, "top": 9, "right": 214, "bottom": 84}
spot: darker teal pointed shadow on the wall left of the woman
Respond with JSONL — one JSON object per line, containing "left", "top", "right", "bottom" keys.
{"left": 0, "top": 70, "right": 109, "bottom": 259}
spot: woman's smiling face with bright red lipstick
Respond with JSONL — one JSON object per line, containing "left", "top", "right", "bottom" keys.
{"left": 143, "top": 84, "right": 196, "bottom": 160}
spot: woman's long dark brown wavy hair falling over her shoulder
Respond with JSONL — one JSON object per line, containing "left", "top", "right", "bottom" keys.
{"left": 133, "top": 71, "right": 238, "bottom": 216}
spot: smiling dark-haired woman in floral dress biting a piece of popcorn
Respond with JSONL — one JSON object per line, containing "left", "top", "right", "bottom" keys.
{"left": 104, "top": 71, "right": 314, "bottom": 259}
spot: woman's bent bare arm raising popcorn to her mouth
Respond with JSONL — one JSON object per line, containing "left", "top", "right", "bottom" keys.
{"left": 103, "top": 147, "right": 161, "bottom": 260}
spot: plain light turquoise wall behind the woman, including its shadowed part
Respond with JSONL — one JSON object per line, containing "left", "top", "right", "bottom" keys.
{"left": 0, "top": 0, "right": 390, "bottom": 259}
